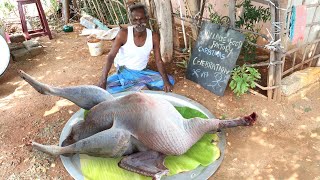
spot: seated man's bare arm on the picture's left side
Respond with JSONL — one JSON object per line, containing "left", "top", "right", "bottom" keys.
{"left": 99, "top": 29, "right": 127, "bottom": 89}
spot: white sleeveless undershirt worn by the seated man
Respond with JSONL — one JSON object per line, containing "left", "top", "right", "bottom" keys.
{"left": 114, "top": 26, "right": 153, "bottom": 71}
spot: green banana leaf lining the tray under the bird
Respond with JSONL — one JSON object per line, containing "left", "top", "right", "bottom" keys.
{"left": 80, "top": 107, "right": 220, "bottom": 180}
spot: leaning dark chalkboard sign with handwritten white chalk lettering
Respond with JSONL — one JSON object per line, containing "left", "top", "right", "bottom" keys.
{"left": 186, "top": 22, "right": 245, "bottom": 96}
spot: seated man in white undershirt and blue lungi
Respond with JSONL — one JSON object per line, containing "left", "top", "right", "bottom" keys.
{"left": 99, "top": 4, "right": 174, "bottom": 94}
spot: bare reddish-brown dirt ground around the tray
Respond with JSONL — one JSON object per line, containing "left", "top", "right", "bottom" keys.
{"left": 0, "top": 29, "right": 320, "bottom": 180}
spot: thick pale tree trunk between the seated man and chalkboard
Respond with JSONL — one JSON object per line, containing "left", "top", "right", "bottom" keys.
{"left": 154, "top": 0, "right": 173, "bottom": 62}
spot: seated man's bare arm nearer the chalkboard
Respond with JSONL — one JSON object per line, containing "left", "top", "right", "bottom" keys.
{"left": 152, "top": 33, "right": 173, "bottom": 92}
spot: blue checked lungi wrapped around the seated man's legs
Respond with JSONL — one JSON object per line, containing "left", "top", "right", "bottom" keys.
{"left": 107, "top": 66, "right": 174, "bottom": 94}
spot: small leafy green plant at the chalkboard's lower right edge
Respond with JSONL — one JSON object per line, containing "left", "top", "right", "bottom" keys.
{"left": 229, "top": 64, "right": 261, "bottom": 96}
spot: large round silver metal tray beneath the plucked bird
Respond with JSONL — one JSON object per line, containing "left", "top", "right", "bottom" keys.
{"left": 59, "top": 91, "right": 226, "bottom": 180}
